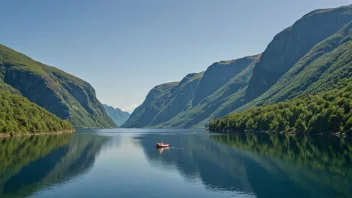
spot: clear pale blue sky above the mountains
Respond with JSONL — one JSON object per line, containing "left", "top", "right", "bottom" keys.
{"left": 0, "top": 0, "right": 352, "bottom": 112}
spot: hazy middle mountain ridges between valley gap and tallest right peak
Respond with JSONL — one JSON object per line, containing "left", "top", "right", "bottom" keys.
{"left": 123, "top": 55, "right": 260, "bottom": 128}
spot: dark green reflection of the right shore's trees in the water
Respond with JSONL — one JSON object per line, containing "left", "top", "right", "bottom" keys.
{"left": 211, "top": 133, "right": 352, "bottom": 176}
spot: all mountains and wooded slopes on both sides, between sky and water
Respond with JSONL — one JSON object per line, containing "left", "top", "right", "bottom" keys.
{"left": 0, "top": 5, "right": 352, "bottom": 133}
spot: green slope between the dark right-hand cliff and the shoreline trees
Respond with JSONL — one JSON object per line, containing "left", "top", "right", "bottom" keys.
{"left": 237, "top": 22, "right": 352, "bottom": 111}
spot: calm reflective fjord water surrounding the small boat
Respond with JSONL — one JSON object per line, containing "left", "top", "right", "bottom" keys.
{"left": 0, "top": 129, "right": 352, "bottom": 198}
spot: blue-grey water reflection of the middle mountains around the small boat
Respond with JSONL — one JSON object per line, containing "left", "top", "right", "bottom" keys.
{"left": 135, "top": 134, "right": 252, "bottom": 193}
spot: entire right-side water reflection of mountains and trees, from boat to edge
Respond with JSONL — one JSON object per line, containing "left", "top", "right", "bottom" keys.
{"left": 136, "top": 134, "right": 352, "bottom": 197}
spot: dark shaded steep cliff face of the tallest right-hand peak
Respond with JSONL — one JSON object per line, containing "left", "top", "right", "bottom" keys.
{"left": 245, "top": 6, "right": 352, "bottom": 101}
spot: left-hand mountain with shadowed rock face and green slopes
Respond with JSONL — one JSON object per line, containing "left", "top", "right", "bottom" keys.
{"left": 0, "top": 45, "right": 116, "bottom": 132}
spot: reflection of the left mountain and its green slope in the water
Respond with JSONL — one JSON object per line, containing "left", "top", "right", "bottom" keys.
{"left": 0, "top": 135, "right": 108, "bottom": 197}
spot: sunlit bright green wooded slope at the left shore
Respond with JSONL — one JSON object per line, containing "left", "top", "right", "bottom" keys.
{"left": 0, "top": 90, "right": 73, "bottom": 134}
